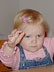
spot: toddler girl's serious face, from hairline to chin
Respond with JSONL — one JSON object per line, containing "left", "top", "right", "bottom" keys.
{"left": 20, "top": 24, "right": 44, "bottom": 52}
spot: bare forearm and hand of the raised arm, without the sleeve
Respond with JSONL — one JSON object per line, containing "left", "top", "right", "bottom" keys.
{"left": 1, "top": 30, "right": 24, "bottom": 56}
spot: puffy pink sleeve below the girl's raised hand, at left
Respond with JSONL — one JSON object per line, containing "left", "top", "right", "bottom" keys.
{"left": 0, "top": 41, "right": 19, "bottom": 67}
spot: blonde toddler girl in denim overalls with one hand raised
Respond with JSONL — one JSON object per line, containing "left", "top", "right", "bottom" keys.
{"left": 0, "top": 9, "right": 54, "bottom": 70}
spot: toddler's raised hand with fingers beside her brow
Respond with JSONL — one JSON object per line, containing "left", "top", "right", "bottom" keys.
{"left": 8, "top": 29, "right": 25, "bottom": 48}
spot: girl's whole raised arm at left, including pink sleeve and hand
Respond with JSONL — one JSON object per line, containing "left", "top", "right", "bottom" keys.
{"left": 0, "top": 31, "right": 24, "bottom": 67}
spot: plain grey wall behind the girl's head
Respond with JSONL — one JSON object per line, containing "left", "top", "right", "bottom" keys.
{"left": 0, "top": 0, "right": 54, "bottom": 40}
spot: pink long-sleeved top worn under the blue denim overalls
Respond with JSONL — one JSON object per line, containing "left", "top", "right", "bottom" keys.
{"left": 0, "top": 37, "right": 54, "bottom": 70}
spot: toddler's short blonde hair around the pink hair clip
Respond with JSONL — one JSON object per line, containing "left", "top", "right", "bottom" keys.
{"left": 14, "top": 9, "right": 49, "bottom": 33}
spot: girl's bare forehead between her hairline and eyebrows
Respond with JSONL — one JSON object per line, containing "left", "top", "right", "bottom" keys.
{"left": 22, "top": 24, "right": 44, "bottom": 34}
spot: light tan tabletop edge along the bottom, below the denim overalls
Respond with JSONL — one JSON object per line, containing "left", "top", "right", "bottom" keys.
{"left": 12, "top": 65, "right": 54, "bottom": 72}
